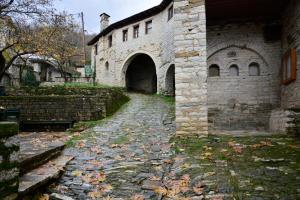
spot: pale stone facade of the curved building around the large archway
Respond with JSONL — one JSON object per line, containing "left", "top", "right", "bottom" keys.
{"left": 92, "top": 1, "right": 174, "bottom": 93}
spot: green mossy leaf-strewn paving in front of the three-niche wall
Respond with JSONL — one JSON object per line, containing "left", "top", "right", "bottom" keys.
{"left": 170, "top": 135, "right": 300, "bottom": 199}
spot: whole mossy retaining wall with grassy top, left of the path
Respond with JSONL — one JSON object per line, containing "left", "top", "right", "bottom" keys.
{"left": 0, "top": 87, "right": 129, "bottom": 122}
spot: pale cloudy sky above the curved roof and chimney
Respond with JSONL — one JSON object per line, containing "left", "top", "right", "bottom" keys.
{"left": 55, "top": 0, "right": 161, "bottom": 33}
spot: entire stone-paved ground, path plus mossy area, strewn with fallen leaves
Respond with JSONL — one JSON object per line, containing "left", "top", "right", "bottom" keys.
{"left": 17, "top": 94, "right": 300, "bottom": 200}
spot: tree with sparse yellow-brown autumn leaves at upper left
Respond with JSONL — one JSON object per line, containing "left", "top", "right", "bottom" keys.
{"left": 0, "top": 0, "right": 76, "bottom": 81}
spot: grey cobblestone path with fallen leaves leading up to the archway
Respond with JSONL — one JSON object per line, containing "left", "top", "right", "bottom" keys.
{"left": 49, "top": 94, "right": 175, "bottom": 200}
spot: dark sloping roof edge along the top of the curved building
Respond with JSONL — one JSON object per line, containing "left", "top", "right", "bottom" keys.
{"left": 88, "top": 0, "right": 173, "bottom": 45}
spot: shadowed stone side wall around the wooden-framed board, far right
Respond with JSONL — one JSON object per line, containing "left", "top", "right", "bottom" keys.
{"left": 281, "top": 0, "right": 300, "bottom": 109}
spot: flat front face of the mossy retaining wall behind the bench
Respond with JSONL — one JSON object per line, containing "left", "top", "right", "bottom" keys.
{"left": 0, "top": 96, "right": 106, "bottom": 121}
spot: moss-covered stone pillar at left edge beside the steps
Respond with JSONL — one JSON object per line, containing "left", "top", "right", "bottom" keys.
{"left": 0, "top": 122, "right": 20, "bottom": 200}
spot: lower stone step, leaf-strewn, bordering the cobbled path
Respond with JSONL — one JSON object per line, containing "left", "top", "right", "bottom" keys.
{"left": 19, "top": 156, "right": 74, "bottom": 197}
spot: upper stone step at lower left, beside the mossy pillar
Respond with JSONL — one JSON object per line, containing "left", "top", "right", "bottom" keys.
{"left": 19, "top": 141, "right": 65, "bottom": 175}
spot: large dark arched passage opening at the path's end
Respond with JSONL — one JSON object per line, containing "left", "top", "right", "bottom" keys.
{"left": 126, "top": 54, "right": 157, "bottom": 94}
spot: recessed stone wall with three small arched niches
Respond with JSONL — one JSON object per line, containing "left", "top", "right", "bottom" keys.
{"left": 207, "top": 23, "right": 281, "bottom": 130}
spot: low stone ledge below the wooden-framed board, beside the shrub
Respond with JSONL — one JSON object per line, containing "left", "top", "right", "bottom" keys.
{"left": 270, "top": 109, "right": 300, "bottom": 136}
